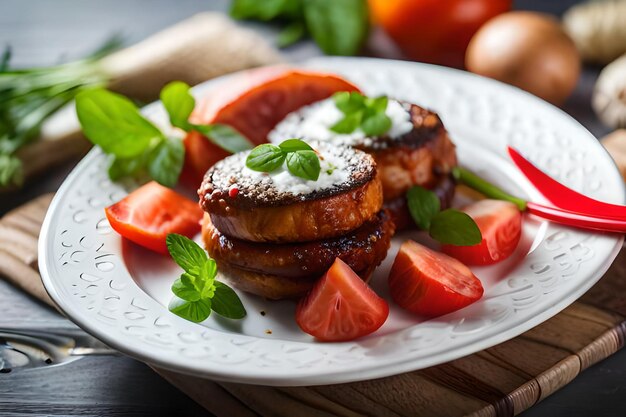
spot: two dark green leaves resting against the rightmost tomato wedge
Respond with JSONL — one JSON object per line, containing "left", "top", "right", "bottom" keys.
{"left": 406, "top": 186, "right": 482, "bottom": 246}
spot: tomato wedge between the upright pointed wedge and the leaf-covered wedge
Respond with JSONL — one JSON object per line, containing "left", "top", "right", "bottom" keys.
{"left": 389, "top": 240, "right": 483, "bottom": 317}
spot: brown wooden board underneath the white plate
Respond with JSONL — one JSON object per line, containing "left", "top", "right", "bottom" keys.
{"left": 0, "top": 195, "right": 626, "bottom": 417}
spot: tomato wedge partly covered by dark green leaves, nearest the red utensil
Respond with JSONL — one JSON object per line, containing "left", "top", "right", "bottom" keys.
{"left": 441, "top": 200, "right": 522, "bottom": 265}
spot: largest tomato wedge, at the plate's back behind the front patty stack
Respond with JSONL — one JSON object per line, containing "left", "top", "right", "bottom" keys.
{"left": 185, "top": 67, "right": 358, "bottom": 183}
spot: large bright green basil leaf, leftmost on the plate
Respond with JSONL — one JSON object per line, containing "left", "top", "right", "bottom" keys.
{"left": 76, "top": 89, "right": 163, "bottom": 158}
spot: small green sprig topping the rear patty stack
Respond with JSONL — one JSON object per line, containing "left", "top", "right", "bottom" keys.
{"left": 330, "top": 91, "right": 392, "bottom": 136}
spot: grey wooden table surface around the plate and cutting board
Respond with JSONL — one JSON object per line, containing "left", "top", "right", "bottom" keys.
{"left": 0, "top": 0, "right": 626, "bottom": 417}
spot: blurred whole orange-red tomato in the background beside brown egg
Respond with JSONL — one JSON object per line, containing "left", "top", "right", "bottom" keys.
{"left": 368, "top": 0, "right": 513, "bottom": 68}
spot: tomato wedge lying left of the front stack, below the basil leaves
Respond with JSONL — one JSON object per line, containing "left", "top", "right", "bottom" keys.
{"left": 104, "top": 181, "right": 203, "bottom": 254}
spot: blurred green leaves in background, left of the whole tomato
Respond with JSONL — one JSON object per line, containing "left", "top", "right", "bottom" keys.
{"left": 230, "top": 0, "right": 369, "bottom": 55}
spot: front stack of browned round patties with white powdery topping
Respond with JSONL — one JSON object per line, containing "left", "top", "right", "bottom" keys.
{"left": 198, "top": 142, "right": 395, "bottom": 299}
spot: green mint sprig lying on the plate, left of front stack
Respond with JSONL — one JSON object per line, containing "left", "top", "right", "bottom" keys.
{"left": 166, "top": 233, "right": 246, "bottom": 323}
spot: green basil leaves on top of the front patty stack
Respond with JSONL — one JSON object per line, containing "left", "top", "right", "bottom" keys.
{"left": 246, "top": 139, "right": 321, "bottom": 181}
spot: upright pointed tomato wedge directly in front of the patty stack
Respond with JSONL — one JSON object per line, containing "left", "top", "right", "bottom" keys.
{"left": 296, "top": 258, "right": 389, "bottom": 342}
